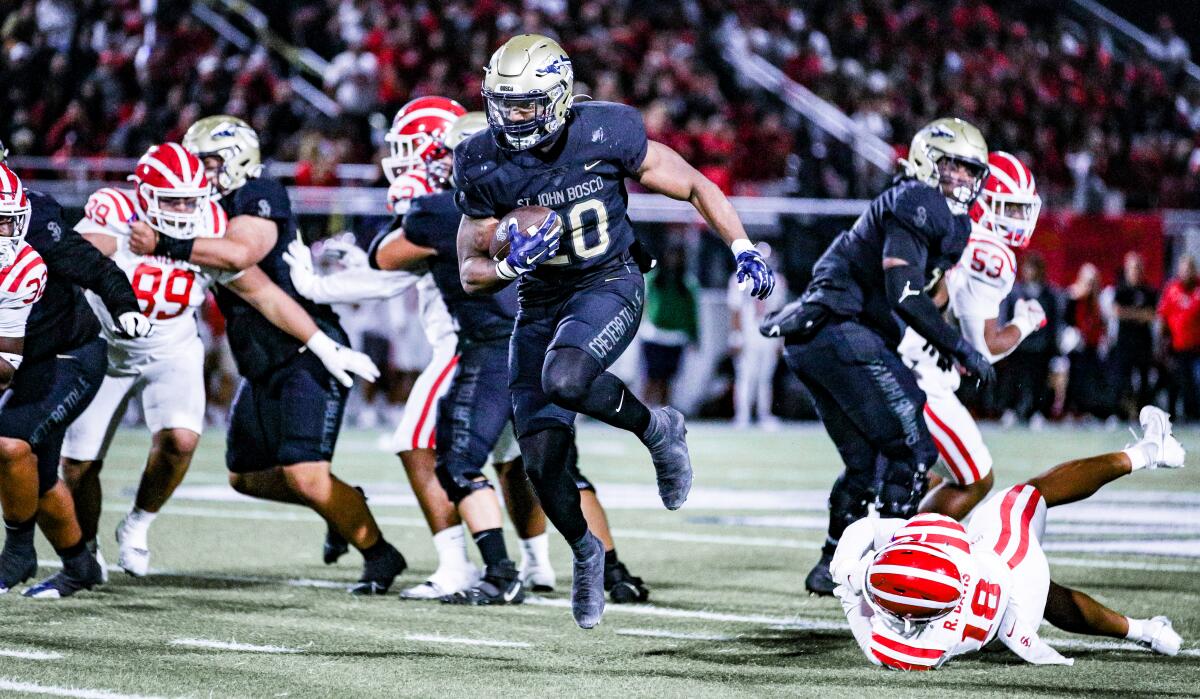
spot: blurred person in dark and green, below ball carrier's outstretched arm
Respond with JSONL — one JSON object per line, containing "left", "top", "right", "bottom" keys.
{"left": 640, "top": 245, "right": 700, "bottom": 406}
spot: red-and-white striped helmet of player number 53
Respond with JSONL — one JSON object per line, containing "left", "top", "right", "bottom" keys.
{"left": 971, "top": 150, "right": 1042, "bottom": 247}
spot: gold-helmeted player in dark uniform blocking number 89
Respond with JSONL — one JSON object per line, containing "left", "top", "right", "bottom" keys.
{"left": 130, "top": 115, "right": 406, "bottom": 595}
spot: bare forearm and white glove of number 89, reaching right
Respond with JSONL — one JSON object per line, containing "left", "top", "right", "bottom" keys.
{"left": 227, "top": 267, "right": 379, "bottom": 387}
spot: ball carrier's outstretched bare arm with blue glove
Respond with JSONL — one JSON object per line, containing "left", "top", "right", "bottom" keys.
{"left": 637, "top": 141, "right": 775, "bottom": 299}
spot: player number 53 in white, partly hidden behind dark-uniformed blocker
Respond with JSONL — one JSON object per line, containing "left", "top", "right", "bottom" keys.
{"left": 899, "top": 151, "right": 1046, "bottom": 519}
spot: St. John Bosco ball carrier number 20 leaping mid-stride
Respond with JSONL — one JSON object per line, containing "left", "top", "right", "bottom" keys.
{"left": 454, "top": 34, "right": 774, "bottom": 628}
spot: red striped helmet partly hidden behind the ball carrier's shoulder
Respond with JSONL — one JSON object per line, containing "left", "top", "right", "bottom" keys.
{"left": 380, "top": 96, "right": 467, "bottom": 189}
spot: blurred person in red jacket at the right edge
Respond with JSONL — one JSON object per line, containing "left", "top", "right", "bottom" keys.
{"left": 1158, "top": 255, "right": 1200, "bottom": 419}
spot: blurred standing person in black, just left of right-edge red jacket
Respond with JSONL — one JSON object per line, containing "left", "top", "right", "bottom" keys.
{"left": 1112, "top": 252, "right": 1158, "bottom": 419}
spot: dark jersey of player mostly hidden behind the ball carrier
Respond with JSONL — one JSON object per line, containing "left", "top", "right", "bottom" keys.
{"left": 372, "top": 192, "right": 517, "bottom": 342}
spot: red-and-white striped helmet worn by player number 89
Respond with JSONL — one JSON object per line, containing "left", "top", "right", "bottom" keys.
{"left": 130, "top": 143, "right": 211, "bottom": 239}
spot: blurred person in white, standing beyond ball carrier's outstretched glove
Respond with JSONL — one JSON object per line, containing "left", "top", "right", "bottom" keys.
{"left": 726, "top": 243, "right": 787, "bottom": 429}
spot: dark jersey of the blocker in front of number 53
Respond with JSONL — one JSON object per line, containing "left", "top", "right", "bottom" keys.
{"left": 803, "top": 178, "right": 971, "bottom": 347}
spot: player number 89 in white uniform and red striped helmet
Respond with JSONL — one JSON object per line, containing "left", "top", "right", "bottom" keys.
{"left": 62, "top": 143, "right": 384, "bottom": 576}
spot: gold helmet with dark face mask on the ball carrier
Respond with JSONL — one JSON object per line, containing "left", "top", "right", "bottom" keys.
{"left": 484, "top": 34, "right": 575, "bottom": 150}
